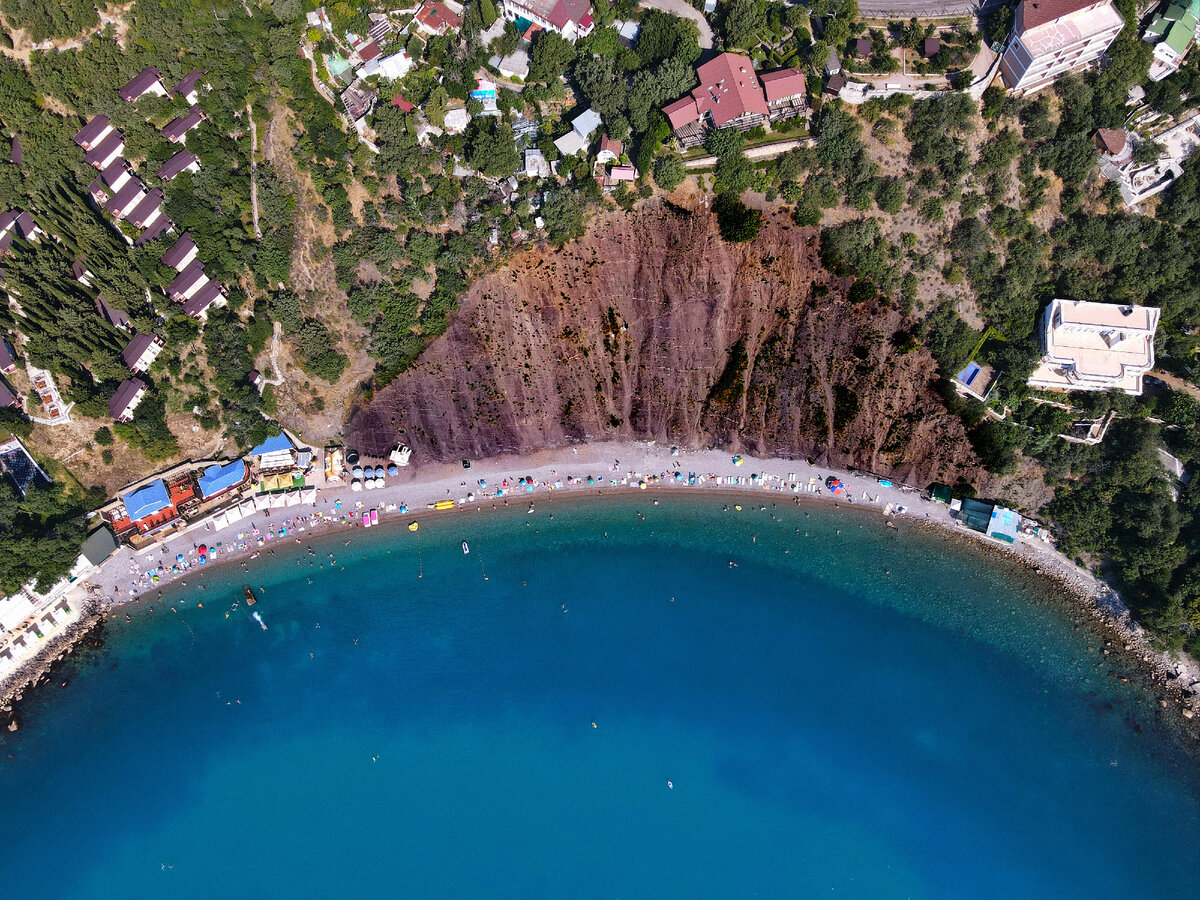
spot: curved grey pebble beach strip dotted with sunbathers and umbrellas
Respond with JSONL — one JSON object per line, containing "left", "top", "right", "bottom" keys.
{"left": 5, "top": 443, "right": 1200, "bottom": 718}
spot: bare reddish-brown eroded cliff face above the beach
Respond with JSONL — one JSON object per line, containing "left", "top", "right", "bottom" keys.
{"left": 348, "top": 203, "right": 977, "bottom": 484}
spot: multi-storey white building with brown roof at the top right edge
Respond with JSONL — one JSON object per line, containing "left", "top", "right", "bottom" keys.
{"left": 1000, "top": 0, "right": 1124, "bottom": 94}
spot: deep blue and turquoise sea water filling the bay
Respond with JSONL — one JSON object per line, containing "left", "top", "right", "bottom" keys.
{"left": 0, "top": 496, "right": 1200, "bottom": 898}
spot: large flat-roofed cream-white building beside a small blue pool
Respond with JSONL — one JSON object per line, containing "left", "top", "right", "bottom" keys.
{"left": 1028, "top": 299, "right": 1160, "bottom": 396}
